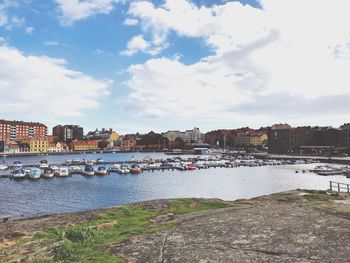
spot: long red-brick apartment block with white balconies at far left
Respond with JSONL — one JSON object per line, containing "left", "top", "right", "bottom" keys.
{"left": 0, "top": 120, "right": 47, "bottom": 142}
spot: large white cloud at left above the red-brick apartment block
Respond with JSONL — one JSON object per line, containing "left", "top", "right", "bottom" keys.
{"left": 0, "top": 46, "right": 111, "bottom": 121}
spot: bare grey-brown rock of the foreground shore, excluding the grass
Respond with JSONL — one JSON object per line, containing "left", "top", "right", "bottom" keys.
{"left": 0, "top": 190, "right": 350, "bottom": 263}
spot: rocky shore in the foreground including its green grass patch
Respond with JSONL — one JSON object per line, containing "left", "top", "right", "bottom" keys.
{"left": 0, "top": 190, "right": 350, "bottom": 263}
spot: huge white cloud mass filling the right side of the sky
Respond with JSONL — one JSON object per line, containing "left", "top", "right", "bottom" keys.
{"left": 128, "top": 0, "right": 350, "bottom": 124}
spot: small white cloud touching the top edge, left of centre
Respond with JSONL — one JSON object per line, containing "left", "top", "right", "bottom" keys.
{"left": 56, "top": 0, "right": 120, "bottom": 26}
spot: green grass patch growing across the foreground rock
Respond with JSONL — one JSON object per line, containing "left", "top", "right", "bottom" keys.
{"left": 30, "top": 199, "right": 228, "bottom": 263}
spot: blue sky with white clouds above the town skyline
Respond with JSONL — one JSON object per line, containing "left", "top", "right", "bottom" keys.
{"left": 0, "top": 0, "right": 350, "bottom": 134}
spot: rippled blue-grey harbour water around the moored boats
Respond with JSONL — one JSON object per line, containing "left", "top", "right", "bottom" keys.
{"left": 0, "top": 153, "right": 350, "bottom": 218}
